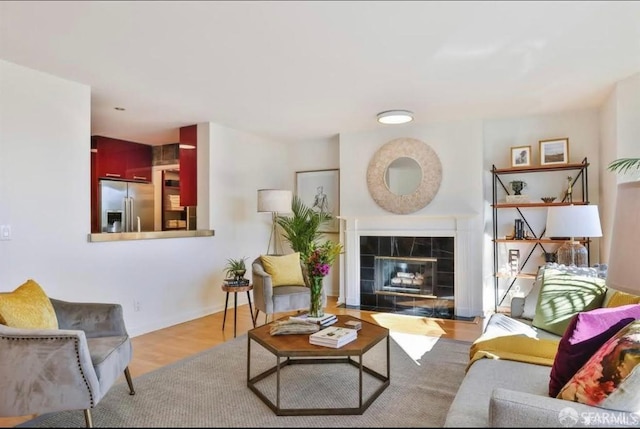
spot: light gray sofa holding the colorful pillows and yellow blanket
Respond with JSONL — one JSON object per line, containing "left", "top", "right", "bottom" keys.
{"left": 444, "top": 266, "right": 640, "bottom": 427}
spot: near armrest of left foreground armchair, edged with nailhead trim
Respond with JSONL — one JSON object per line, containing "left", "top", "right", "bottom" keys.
{"left": 0, "top": 325, "right": 101, "bottom": 416}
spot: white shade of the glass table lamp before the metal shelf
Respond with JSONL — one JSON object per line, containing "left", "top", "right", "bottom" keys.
{"left": 545, "top": 205, "right": 602, "bottom": 238}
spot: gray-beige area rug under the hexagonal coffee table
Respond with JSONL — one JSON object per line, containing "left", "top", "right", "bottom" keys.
{"left": 20, "top": 332, "right": 470, "bottom": 427}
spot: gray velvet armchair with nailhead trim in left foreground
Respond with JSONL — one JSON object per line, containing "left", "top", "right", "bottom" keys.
{"left": 0, "top": 299, "right": 135, "bottom": 427}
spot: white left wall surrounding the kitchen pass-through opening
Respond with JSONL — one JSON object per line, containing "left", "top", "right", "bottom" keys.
{"left": 0, "top": 61, "right": 291, "bottom": 335}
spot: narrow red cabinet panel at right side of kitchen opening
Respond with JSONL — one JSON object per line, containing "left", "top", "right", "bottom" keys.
{"left": 180, "top": 125, "right": 198, "bottom": 207}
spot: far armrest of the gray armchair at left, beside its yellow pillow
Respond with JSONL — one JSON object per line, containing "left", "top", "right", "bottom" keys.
{"left": 50, "top": 299, "right": 128, "bottom": 338}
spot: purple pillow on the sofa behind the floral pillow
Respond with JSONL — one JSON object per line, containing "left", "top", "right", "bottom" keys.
{"left": 549, "top": 304, "right": 640, "bottom": 398}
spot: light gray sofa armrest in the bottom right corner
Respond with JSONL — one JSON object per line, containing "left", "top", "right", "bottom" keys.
{"left": 487, "top": 388, "right": 640, "bottom": 428}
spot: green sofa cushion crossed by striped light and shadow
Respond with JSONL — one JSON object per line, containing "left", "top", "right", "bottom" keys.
{"left": 531, "top": 268, "right": 607, "bottom": 336}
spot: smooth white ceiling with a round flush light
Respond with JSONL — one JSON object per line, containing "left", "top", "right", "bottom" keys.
{"left": 0, "top": 1, "right": 640, "bottom": 144}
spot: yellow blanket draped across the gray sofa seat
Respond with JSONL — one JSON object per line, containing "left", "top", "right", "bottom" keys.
{"left": 467, "top": 335, "right": 559, "bottom": 370}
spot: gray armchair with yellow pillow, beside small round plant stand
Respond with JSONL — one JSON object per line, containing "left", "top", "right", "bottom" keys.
{"left": 251, "top": 252, "right": 326, "bottom": 322}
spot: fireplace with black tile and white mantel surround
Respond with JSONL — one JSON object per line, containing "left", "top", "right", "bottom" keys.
{"left": 339, "top": 215, "right": 481, "bottom": 318}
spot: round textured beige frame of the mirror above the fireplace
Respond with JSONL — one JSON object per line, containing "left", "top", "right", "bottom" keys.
{"left": 367, "top": 137, "right": 442, "bottom": 214}
